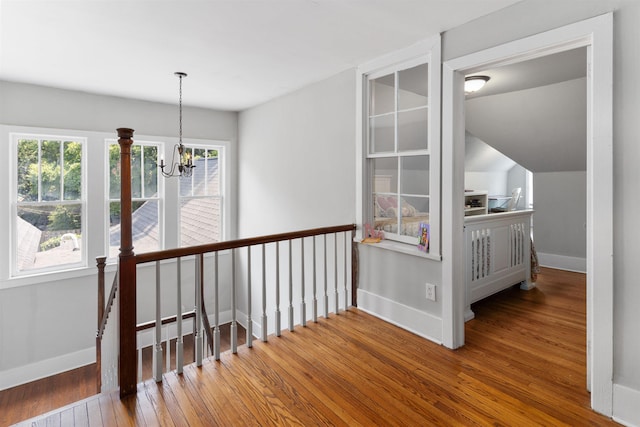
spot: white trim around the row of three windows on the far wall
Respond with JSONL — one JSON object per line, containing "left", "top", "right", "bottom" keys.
{"left": 0, "top": 124, "right": 238, "bottom": 289}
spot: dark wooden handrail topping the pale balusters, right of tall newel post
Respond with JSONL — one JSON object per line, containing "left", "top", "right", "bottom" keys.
{"left": 135, "top": 224, "right": 356, "bottom": 264}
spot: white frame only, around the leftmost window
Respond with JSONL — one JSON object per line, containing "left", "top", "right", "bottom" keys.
{"left": 9, "top": 132, "right": 88, "bottom": 278}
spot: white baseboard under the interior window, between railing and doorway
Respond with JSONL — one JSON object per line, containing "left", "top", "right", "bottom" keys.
{"left": 358, "top": 289, "right": 442, "bottom": 344}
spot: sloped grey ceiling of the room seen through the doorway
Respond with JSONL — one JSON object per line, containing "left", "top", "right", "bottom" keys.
{"left": 465, "top": 47, "right": 587, "bottom": 172}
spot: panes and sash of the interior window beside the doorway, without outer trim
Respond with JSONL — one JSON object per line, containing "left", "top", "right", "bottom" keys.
{"left": 367, "top": 63, "right": 430, "bottom": 243}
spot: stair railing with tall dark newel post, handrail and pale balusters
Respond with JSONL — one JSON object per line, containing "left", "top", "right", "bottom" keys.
{"left": 111, "top": 128, "right": 357, "bottom": 397}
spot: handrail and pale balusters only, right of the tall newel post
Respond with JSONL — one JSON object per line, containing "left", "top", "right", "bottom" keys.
{"left": 125, "top": 224, "right": 357, "bottom": 388}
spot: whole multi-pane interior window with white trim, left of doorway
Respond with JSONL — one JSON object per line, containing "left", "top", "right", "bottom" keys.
{"left": 358, "top": 37, "right": 440, "bottom": 259}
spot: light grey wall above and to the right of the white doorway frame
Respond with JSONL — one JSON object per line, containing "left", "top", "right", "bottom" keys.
{"left": 443, "top": 0, "right": 640, "bottom": 425}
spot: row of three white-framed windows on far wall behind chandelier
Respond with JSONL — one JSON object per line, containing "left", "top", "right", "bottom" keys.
{"left": 0, "top": 124, "right": 236, "bottom": 289}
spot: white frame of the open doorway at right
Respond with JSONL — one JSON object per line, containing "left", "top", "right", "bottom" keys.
{"left": 441, "top": 13, "right": 613, "bottom": 416}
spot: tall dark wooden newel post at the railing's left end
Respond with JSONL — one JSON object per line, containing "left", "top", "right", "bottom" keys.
{"left": 118, "top": 128, "right": 137, "bottom": 397}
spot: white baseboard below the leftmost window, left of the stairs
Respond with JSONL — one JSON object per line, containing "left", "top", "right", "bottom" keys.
{"left": 0, "top": 347, "right": 96, "bottom": 390}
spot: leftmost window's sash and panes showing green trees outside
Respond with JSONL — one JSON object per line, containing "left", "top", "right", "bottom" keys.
{"left": 12, "top": 134, "right": 86, "bottom": 275}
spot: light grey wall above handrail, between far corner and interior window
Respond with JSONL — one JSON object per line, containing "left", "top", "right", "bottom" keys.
{"left": 238, "top": 70, "right": 355, "bottom": 237}
